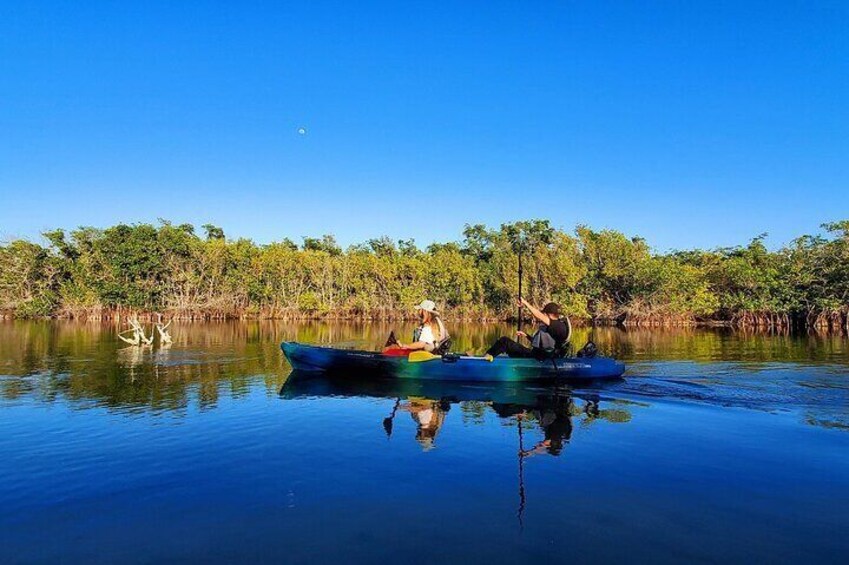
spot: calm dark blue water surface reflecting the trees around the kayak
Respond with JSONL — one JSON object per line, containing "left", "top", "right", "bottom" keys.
{"left": 0, "top": 322, "right": 849, "bottom": 563}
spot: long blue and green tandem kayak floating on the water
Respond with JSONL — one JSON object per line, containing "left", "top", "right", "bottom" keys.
{"left": 280, "top": 341, "right": 625, "bottom": 382}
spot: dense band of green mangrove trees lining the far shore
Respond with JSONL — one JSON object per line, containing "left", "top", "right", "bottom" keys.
{"left": 0, "top": 220, "right": 849, "bottom": 329}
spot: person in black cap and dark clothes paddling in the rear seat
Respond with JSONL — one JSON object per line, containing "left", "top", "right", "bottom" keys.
{"left": 485, "top": 298, "right": 572, "bottom": 361}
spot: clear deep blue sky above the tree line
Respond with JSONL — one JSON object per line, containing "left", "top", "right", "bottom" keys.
{"left": 0, "top": 0, "right": 849, "bottom": 250}
